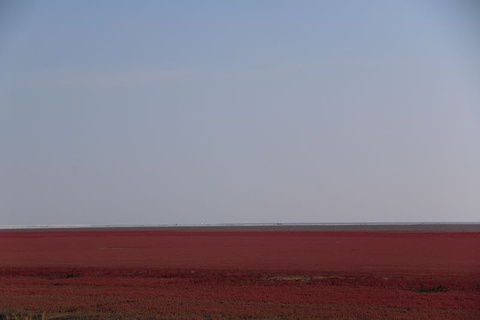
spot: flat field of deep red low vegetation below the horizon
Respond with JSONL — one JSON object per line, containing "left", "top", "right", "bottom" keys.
{"left": 0, "top": 229, "right": 480, "bottom": 319}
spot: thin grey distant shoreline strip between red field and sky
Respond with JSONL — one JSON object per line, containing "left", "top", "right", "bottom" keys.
{"left": 0, "top": 223, "right": 480, "bottom": 232}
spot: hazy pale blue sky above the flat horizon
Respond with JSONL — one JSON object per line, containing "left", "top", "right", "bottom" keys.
{"left": 0, "top": 0, "right": 480, "bottom": 225}
